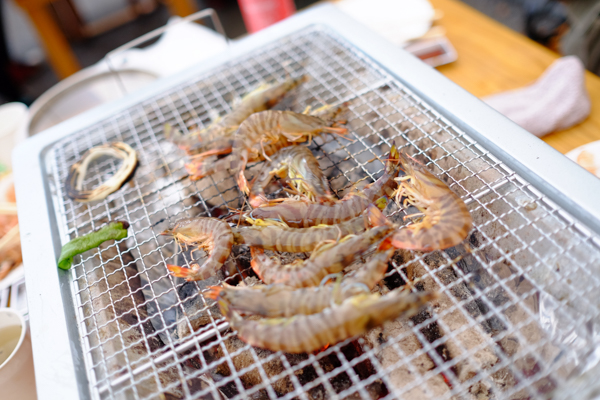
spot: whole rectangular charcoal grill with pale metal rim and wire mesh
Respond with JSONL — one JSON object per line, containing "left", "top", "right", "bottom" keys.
{"left": 14, "top": 5, "right": 600, "bottom": 399}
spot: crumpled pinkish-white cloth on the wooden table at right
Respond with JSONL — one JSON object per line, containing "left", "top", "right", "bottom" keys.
{"left": 483, "top": 56, "right": 591, "bottom": 136}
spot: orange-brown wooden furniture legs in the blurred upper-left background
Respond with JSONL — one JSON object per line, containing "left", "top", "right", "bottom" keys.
{"left": 15, "top": 0, "right": 196, "bottom": 79}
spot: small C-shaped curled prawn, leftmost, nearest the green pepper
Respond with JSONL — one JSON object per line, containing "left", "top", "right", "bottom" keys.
{"left": 162, "top": 217, "right": 233, "bottom": 281}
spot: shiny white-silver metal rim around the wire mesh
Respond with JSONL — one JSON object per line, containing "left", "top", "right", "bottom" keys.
{"left": 14, "top": 5, "right": 600, "bottom": 399}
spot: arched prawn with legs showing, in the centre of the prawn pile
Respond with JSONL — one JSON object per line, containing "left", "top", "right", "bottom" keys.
{"left": 249, "top": 146, "right": 332, "bottom": 207}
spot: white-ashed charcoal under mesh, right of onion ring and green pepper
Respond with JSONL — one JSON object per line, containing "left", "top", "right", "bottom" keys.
{"left": 120, "top": 158, "right": 204, "bottom": 343}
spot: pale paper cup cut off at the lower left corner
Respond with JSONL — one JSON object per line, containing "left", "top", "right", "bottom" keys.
{"left": 0, "top": 308, "right": 37, "bottom": 400}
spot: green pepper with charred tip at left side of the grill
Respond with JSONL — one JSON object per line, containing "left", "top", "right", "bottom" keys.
{"left": 58, "top": 221, "right": 129, "bottom": 269}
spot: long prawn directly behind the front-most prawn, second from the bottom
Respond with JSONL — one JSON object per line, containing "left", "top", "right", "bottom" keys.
{"left": 206, "top": 249, "right": 394, "bottom": 318}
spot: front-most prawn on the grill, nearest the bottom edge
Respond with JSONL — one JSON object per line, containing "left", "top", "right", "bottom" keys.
{"left": 219, "top": 289, "right": 438, "bottom": 353}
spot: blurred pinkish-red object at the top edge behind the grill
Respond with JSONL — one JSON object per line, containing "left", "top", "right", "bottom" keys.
{"left": 238, "top": 0, "right": 296, "bottom": 33}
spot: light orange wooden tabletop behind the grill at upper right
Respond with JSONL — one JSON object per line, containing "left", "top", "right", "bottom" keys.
{"left": 429, "top": 0, "right": 600, "bottom": 153}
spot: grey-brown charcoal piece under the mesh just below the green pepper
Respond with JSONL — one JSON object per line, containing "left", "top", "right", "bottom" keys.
{"left": 78, "top": 239, "right": 184, "bottom": 399}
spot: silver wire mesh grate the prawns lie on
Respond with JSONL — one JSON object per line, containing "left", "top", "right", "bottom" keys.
{"left": 49, "top": 27, "right": 600, "bottom": 399}
